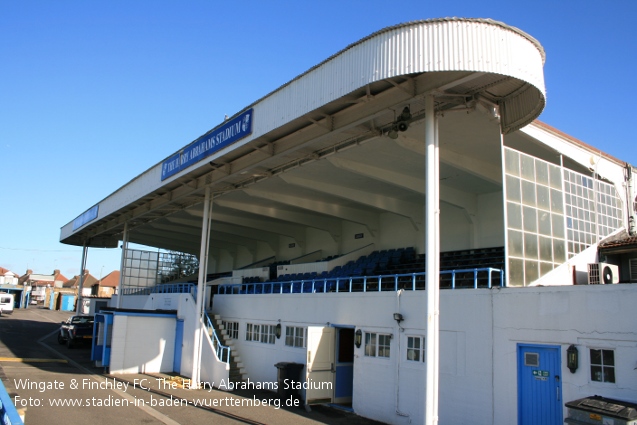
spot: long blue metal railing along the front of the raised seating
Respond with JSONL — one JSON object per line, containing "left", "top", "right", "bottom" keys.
{"left": 218, "top": 267, "right": 504, "bottom": 294}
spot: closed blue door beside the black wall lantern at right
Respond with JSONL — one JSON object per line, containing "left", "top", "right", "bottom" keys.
{"left": 518, "top": 344, "right": 564, "bottom": 425}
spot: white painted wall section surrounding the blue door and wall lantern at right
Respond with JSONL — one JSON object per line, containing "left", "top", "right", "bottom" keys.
{"left": 493, "top": 285, "right": 637, "bottom": 424}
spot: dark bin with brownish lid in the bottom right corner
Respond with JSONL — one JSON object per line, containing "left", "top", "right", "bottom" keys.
{"left": 564, "top": 395, "right": 637, "bottom": 425}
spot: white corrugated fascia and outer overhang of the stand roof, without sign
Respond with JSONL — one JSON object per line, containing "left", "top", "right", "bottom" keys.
{"left": 60, "top": 18, "right": 545, "bottom": 246}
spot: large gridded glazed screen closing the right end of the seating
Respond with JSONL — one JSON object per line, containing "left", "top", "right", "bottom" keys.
{"left": 504, "top": 148, "right": 622, "bottom": 286}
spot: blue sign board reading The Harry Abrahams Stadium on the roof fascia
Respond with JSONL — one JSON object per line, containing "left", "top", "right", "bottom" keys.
{"left": 161, "top": 109, "right": 253, "bottom": 180}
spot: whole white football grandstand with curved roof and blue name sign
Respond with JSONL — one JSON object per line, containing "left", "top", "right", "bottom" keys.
{"left": 60, "top": 18, "right": 637, "bottom": 425}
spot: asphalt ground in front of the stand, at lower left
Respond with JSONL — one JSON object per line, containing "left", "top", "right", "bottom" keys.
{"left": 0, "top": 308, "right": 380, "bottom": 425}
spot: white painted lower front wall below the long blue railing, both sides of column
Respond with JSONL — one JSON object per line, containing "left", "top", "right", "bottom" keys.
{"left": 215, "top": 285, "right": 637, "bottom": 425}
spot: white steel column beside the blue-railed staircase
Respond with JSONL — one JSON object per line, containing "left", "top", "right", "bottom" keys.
{"left": 191, "top": 187, "right": 211, "bottom": 388}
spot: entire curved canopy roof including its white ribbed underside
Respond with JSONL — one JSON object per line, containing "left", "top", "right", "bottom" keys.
{"left": 60, "top": 18, "right": 545, "bottom": 253}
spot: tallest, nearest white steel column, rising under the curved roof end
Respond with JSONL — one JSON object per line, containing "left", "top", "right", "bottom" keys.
{"left": 425, "top": 95, "right": 440, "bottom": 425}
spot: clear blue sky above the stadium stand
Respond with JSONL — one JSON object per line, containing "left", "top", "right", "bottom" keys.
{"left": 0, "top": 0, "right": 637, "bottom": 278}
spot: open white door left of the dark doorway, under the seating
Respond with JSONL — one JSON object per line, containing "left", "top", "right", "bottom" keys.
{"left": 305, "top": 326, "right": 336, "bottom": 404}
